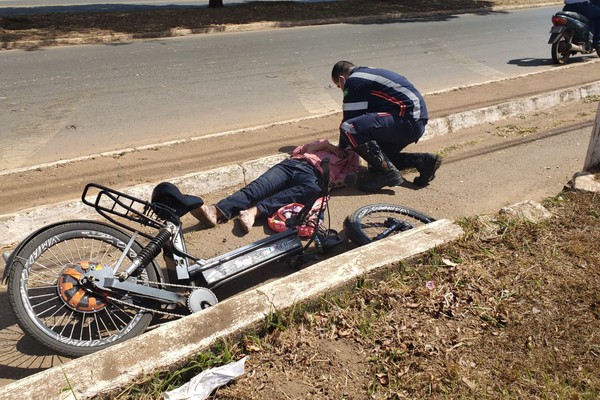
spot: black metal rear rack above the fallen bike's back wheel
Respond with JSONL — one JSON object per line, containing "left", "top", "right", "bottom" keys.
{"left": 81, "top": 183, "right": 168, "bottom": 239}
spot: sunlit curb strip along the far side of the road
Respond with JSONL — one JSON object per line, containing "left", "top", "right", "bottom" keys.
{"left": 0, "top": 1, "right": 563, "bottom": 50}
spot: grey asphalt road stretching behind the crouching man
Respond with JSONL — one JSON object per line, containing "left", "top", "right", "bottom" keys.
{"left": 0, "top": 7, "right": 572, "bottom": 171}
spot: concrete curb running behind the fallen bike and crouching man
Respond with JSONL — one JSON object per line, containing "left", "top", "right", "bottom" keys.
{"left": 0, "top": 81, "right": 600, "bottom": 247}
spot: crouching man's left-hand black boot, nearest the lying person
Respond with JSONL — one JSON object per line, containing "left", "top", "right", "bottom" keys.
{"left": 355, "top": 141, "right": 404, "bottom": 192}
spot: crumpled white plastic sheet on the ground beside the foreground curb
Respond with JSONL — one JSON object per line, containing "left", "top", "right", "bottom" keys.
{"left": 164, "top": 357, "right": 248, "bottom": 400}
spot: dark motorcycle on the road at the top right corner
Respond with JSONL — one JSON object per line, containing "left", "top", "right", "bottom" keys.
{"left": 548, "top": 11, "right": 600, "bottom": 65}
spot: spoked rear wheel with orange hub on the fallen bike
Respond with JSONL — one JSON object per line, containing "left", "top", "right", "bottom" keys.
{"left": 8, "top": 221, "right": 158, "bottom": 357}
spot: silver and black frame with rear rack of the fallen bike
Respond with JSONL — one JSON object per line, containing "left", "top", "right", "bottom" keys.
{"left": 75, "top": 183, "right": 326, "bottom": 303}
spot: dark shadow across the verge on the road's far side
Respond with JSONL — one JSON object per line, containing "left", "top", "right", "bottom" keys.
{"left": 0, "top": 0, "right": 524, "bottom": 43}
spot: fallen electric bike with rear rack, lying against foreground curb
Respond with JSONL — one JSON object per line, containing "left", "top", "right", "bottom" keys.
{"left": 3, "top": 160, "right": 434, "bottom": 357}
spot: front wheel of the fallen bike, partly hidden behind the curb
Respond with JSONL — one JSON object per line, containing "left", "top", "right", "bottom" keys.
{"left": 344, "top": 203, "right": 435, "bottom": 246}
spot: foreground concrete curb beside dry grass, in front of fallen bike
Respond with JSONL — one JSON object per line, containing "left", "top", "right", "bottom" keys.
{"left": 0, "top": 220, "right": 463, "bottom": 400}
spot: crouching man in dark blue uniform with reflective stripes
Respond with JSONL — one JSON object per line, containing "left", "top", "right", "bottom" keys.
{"left": 331, "top": 61, "right": 441, "bottom": 192}
